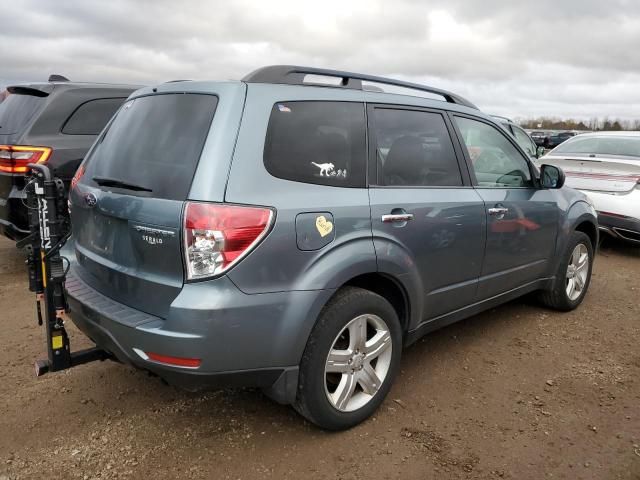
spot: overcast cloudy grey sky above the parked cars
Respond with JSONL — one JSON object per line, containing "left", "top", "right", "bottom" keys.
{"left": 0, "top": 0, "right": 640, "bottom": 119}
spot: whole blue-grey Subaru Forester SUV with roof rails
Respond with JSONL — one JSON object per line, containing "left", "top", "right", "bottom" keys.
{"left": 67, "top": 66, "right": 598, "bottom": 429}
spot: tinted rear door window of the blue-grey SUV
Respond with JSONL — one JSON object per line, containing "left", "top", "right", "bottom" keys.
{"left": 374, "top": 108, "right": 462, "bottom": 187}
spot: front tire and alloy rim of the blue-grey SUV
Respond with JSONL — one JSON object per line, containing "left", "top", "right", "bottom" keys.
{"left": 540, "top": 232, "right": 594, "bottom": 312}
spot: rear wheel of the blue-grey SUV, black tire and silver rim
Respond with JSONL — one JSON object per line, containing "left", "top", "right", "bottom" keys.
{"left": 294, "top": 287, "right": 402, "bottom": 430}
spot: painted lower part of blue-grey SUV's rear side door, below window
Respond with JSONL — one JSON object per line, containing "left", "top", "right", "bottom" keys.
{"left": 370, "top": 188, "right": 485, "bottom": 320}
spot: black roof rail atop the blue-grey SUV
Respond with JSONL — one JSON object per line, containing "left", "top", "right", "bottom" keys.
{"left": 242, "top": 65, "right": 478, "bottom": 110}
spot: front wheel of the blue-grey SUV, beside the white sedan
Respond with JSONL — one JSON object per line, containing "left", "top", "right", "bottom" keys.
{"left": 541, "top": 232, "right": 593, "bottom": 311}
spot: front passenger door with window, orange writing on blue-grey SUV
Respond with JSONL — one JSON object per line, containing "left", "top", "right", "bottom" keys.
{"left": 454, "top": 115, "right": 559, "bottom": 300}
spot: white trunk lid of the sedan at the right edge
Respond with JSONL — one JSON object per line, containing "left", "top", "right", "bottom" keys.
{"left": 542, "top": 155, "right": 640, "bottom": 194}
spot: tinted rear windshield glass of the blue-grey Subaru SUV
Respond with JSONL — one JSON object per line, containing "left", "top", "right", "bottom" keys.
{"left": 83, "top": 93, "right": 218, "bottom": 200}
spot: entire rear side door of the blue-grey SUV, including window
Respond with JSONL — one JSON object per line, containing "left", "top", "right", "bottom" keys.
{"left": 368, "top": 105, "right": 486, "bottom": 320}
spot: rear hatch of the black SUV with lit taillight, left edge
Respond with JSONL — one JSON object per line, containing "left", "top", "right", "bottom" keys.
{"left": 0, "top": 84, "right": 53, "bottom": 227}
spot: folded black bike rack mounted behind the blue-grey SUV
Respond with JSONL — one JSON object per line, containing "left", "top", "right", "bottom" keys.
{"left": 16, "top": 164, "right": 111, "bottom": 376}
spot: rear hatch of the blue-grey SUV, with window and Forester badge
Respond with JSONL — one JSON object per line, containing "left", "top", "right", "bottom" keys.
{"left": 70, "top": 92, "right": 218, "bottom": 317}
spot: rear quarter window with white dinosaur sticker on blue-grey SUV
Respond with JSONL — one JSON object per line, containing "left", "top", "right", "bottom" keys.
{"left": 264, "top": 101, "right": 366, "bottom": 187}
